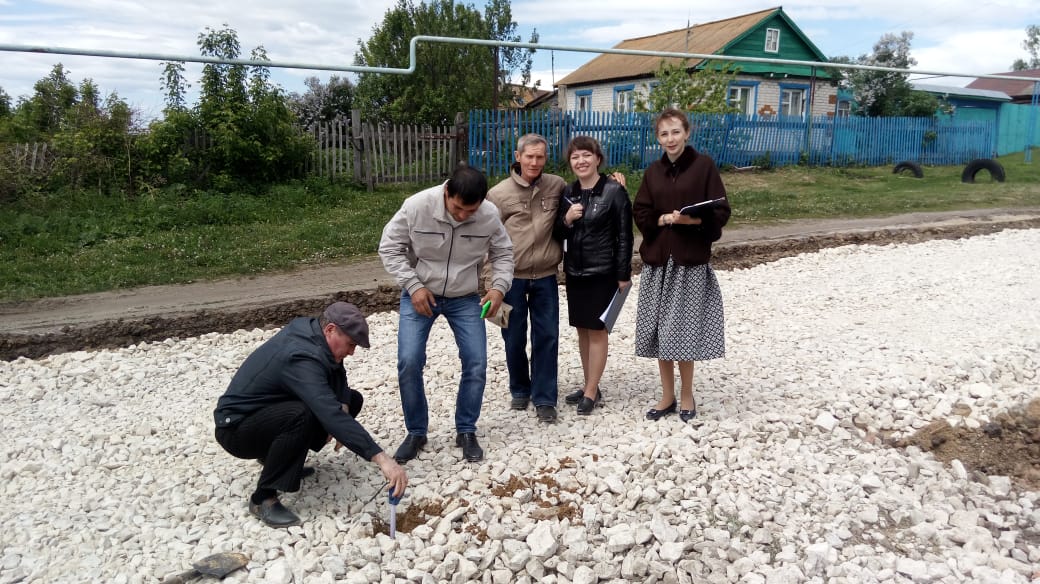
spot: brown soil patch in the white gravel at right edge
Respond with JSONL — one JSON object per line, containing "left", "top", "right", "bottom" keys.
{"left": 891, "top": 399, "right": 1040, "bottom": 490}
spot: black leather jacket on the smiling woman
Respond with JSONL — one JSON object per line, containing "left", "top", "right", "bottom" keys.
{"left": 552, "top": 174, "right": 632, "bottom": 282}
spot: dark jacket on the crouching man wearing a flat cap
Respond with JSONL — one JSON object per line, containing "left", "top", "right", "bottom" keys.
{"left": 213, "top": 318, "right": 383, "bottom": 460}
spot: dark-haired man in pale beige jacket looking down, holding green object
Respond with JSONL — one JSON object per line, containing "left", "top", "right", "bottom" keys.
{"left": 380, "top": 166, "right": 513, "bottom": 462}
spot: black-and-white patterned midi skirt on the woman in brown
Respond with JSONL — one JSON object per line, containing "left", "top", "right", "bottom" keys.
{"left": 635, "top": 258, "right": 726, "bottom": 361}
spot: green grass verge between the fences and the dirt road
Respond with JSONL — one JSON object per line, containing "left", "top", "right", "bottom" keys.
{"left": 0, "top": 154, "right": 1040, "bottom": 301}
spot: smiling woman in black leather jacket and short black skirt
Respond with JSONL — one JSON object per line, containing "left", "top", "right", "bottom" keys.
{"left": 553, "top": 136, "right": 632, "bottom": 416}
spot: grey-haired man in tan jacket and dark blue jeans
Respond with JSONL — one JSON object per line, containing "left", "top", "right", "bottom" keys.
{"left": 488, "top": 134, "right": 566, "bottom": 423}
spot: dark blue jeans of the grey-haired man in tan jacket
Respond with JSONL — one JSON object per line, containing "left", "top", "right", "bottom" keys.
{"left": 502, "top": 274, "right": 560, "bottom": 406}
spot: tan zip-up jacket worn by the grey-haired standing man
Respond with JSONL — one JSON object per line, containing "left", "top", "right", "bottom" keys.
{"left": 488, "top": 164, "right": 567, "bottom": 280}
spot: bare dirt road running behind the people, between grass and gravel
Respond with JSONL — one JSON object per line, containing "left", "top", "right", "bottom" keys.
{"left": 0, "top": 208, "right": 1040, "bottom": 360}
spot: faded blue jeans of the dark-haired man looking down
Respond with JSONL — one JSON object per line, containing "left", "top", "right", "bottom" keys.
{"left": 397, "top": 292, "right": 488, "bottom": 436}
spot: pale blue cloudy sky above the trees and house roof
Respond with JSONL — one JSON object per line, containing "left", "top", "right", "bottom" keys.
{"left": 0, "top": 0, "right": 1040, "bottom": 117}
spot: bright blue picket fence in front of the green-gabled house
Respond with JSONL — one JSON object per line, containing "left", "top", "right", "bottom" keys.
{"left": 468, "top": 110, "right": 996, "bottom": 176}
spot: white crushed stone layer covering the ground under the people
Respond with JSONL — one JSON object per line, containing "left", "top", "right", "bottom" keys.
{"left": 0, "top": 230, "right": 1040, "bottom": 584}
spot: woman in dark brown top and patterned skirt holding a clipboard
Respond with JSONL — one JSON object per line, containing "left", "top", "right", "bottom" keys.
{"left": 632, "top": 108, "right": 730, "bottom": 422}
